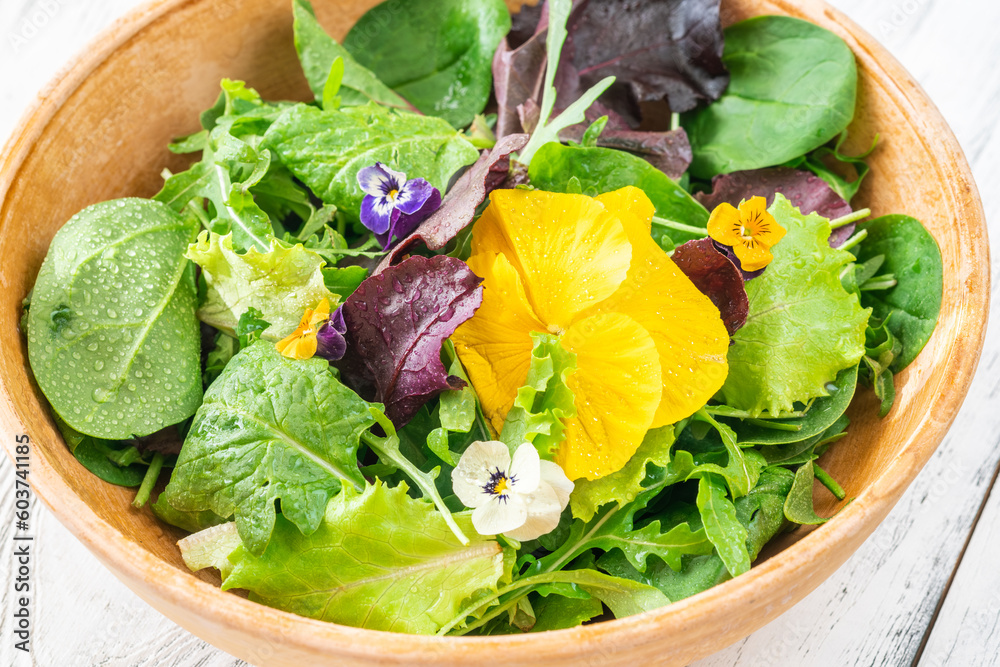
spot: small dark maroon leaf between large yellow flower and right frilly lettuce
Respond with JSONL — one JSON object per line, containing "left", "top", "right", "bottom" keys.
{"left": 671, "top": 239, "right": 750, "bottom": 336}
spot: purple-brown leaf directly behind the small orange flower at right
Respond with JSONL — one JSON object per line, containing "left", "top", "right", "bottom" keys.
{"left": 695, "top": 167, "right": 854, "bottom": 247}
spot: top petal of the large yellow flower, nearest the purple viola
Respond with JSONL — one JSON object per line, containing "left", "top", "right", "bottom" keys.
{"left": 472, "top": 190, "right": 632, "bottom": 333}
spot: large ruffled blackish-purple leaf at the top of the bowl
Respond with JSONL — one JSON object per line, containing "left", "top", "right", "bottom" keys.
{"left": 558, "top": 0, "right": 729, "bottom": 118}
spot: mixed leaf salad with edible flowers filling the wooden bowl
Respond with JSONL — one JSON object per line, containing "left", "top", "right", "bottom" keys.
{"left": 22, "top": 0, "right": 942, "bottom": 635}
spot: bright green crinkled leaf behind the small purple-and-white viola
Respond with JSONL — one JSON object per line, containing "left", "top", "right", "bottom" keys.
{"left": 264, "top": 105, "right": 479, "bottom": 222}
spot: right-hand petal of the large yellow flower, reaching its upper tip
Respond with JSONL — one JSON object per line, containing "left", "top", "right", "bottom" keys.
{"left": 587, "top": 188, "right": 735, "bottom": 428}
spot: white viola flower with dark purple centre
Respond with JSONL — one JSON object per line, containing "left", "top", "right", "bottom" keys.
{"left": 451, "top": 440, "right": 573, "bottom": 541}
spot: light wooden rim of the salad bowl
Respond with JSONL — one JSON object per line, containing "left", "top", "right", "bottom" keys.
{"left": 0, "top": 0, "right": 990, "bottom": 661}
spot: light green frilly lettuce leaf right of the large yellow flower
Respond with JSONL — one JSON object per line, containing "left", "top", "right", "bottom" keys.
{"left": 721, "top": 194, "right": 871, "bottom": 416}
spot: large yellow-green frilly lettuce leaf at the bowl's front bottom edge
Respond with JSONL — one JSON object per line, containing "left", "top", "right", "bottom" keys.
{"left": 222, "top": 482, "right": 505, "bottom": 634}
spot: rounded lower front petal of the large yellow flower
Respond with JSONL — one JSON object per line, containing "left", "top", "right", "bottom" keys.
{"left": 556, "top": 314, "right": 663, "bottom": 480}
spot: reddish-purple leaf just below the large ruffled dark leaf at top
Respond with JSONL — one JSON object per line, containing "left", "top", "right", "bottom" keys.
{"left": 559, "top": 102, "right": 692, "bottom": 180}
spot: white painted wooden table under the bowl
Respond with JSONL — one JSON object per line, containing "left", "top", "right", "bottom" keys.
{"left": 0, "top": 0, "right": 1000, "bottom": 667}
